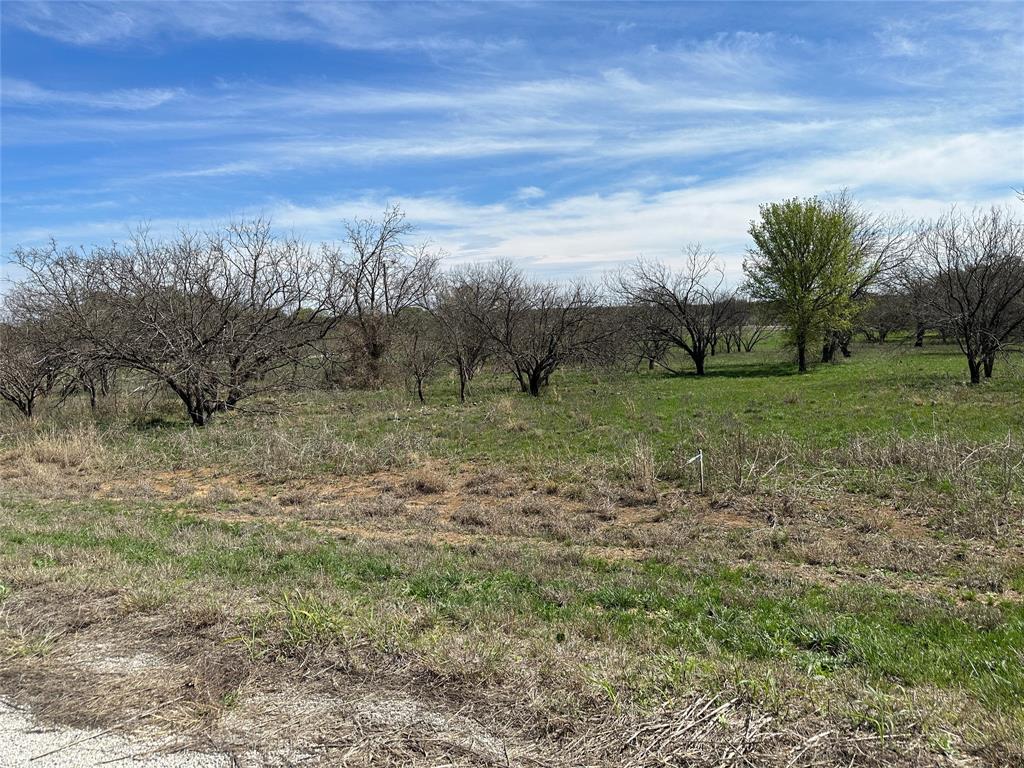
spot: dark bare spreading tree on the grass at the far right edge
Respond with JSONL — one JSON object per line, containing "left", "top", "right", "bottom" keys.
{"left": 903, "top": 207, "right": 1024, "bottom": 384}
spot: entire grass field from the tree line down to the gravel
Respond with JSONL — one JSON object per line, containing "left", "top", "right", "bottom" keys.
{"left": 0, "top": 344, "right": 1024, "bottom": 766}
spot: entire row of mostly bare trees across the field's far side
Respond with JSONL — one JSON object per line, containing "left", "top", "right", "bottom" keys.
{"left": 0, "top": 193, "right": 1024, "bottom": 426}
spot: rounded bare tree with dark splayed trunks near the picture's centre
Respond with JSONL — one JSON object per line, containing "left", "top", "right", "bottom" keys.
{"left": 470, "top": 261, "right": 600, "bottom": 396}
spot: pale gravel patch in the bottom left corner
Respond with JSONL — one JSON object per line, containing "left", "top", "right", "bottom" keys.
{"left": 0, "top": 699, "right": 231, "bottom": 768}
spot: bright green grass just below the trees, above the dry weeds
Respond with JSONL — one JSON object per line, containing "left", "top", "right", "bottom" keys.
{"left": 25, "top": 343, "right": 1024, "bottom": 463}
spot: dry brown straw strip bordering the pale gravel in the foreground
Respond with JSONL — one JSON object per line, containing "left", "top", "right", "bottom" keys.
{"left": 0, "top": 586, "right": 1010, "bottom": 768}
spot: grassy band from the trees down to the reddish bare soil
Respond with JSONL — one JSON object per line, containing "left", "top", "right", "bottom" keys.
{"left": 36, "top": 343, "right": 1024, "bottom": 512}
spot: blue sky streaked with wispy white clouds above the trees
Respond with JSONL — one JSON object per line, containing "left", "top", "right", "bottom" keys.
{"left": 0, "top": 1, "right": 1024, "bottom": 276}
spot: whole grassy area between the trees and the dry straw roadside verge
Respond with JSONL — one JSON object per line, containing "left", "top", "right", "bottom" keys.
{"left": 0, "top": 344, "right": 1024, "bottom": 755}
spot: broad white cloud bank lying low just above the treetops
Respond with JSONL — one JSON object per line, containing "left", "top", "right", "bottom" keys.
{"left": 13, "top": 131, "right": 1019, "bottom": 283}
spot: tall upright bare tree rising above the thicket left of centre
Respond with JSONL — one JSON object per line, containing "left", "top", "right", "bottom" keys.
{"left": 340, "top": 206, "right": 438, "bottom": 387}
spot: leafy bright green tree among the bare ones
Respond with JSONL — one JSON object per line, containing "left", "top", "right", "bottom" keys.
{"left": 743, "top": 198, "right": 865, "bottom": 372}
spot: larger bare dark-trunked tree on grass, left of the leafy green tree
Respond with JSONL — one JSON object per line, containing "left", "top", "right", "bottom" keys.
{"left": 614, "top": 245, "right": 735, "bottom": 376}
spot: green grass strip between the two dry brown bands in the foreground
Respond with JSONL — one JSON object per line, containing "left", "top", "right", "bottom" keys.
{"left": 0, "top": 500, "right": 1024, "bottom": 718}
